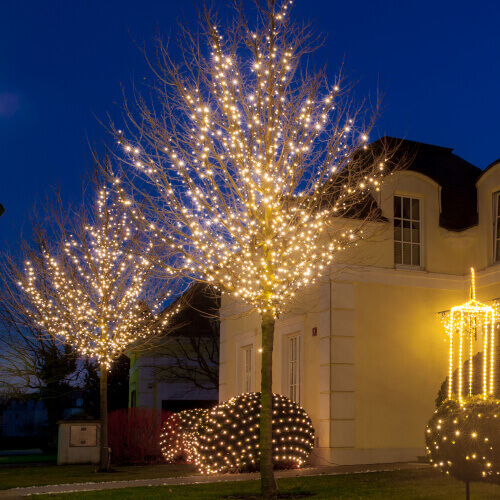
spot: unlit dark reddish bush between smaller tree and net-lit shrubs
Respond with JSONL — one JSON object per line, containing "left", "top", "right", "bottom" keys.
{"left": 108, "top": 408, "right": 172, "bottom": 463}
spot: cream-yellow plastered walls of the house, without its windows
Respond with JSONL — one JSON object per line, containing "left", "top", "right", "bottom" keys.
{"left": 219, "top": 156, "right": 500, "bottom": 464}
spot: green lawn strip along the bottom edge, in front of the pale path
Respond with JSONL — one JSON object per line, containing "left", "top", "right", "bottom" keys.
{"left": 36, "top": 469, "right": 500, "bottom": 500}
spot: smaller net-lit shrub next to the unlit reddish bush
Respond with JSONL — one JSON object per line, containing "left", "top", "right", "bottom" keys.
{"left": 160, "top": 409, "right": 208, "bottom": 465}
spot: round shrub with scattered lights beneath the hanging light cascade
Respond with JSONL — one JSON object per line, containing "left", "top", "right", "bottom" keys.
{"left": 426, "top": 397, "right": 500, "bottom": 482}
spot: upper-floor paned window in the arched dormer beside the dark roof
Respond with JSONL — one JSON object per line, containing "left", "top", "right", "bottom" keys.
{"left": 394, "top": 196, "right": 422, "bottom": 266}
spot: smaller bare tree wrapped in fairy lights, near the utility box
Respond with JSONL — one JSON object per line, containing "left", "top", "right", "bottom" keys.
{"left": 7, "top": 184, "right": 176, "bottom": 471}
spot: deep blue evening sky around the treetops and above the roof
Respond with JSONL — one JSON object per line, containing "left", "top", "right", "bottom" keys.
{"left": 0, "top": 0, "right": 500, "bottom": 249}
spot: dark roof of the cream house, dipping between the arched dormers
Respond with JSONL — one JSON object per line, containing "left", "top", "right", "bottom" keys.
{"left": 372, "top": 137, "right": 482, "bottom": 231}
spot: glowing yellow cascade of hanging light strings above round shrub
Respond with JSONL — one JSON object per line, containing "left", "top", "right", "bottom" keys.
{"left": 443, "top": 268, "right": 498, "bottom": 404}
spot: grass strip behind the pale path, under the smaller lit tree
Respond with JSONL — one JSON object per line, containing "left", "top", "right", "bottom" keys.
{"left": 0, "top": 464, "right": 197, "bottom": 490}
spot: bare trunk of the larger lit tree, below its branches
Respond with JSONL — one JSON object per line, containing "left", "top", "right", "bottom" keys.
{"left": 260, "top": 312, "right": 278, "bottom": 498}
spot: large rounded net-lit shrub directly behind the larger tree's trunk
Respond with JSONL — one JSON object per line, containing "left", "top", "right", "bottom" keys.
{"left": 197, "top": 393, "right": 314, "bottom": 474}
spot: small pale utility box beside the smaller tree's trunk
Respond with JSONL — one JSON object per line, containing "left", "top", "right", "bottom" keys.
{"left": 57, "top": 420, "right": 101, "bottom": 465}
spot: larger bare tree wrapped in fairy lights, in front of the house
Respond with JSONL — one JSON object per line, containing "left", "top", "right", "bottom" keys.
{"left": 115, "top": 0, "right": 402, "bottom": 497}
